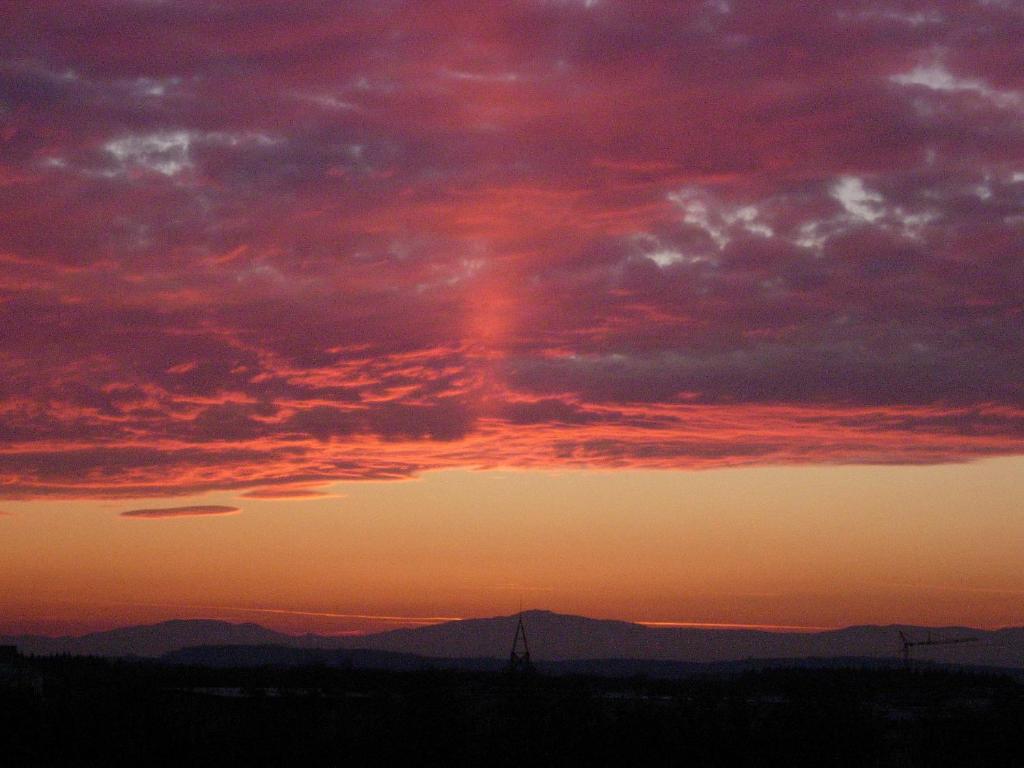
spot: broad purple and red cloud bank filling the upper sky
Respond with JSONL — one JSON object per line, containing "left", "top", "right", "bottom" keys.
{"left": 0, "top": 0, "right": 1024, "bottom": 499}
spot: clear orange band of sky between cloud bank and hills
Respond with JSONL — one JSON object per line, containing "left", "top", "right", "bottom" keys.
{"left": 0, "top": 459, "right": 1024, "bottom": 634}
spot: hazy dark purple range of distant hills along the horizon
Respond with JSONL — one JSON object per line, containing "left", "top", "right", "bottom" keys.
{"left": 0, "top": 610, "right": 1024, "bottom": 668}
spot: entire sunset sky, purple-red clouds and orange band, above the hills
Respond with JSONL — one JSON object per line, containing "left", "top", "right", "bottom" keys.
{"left": 0, "top": 0, "right": 1024, "bottom": 633}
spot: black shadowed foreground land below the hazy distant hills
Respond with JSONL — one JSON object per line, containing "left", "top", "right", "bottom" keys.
{"left": 0, "top": 657, "right": 1024, "bottom": 766}
